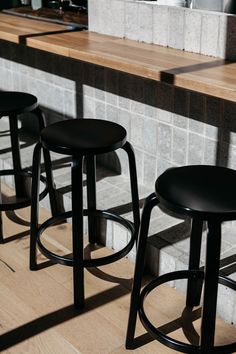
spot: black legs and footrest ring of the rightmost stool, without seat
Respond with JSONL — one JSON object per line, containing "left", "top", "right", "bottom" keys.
{"left": 126, "top": 193, "right": 236, "bottom": 353}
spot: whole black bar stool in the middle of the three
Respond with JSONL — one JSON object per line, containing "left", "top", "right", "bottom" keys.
{"left": 30, "top": 119, "right": 140, "bottom": 308}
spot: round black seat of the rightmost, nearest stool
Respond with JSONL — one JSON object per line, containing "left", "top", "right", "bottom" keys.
{"left": 155, "top": 165, "right": 236, "bottom": 219}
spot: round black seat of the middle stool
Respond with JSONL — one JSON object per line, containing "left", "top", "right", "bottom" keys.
{"left": 41, "top": 119, "right": 126, "bottom": 155}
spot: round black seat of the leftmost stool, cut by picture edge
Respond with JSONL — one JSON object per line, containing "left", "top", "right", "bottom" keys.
{"left": 0, "top": 91, "right": 38, "bottom": 116}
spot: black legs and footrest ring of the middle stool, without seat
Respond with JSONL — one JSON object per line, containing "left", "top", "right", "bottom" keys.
{"left": 30, "top": 137, "right": 140, "bottom": 309}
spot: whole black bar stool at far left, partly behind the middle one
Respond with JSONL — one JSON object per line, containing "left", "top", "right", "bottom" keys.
{"left": 0, "top": 91, "right": 57, "bottom": 243}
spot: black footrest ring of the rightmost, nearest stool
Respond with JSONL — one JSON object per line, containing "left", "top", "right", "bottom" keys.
{"left": 139, "top": 270, "right": 236, "bottom": 354}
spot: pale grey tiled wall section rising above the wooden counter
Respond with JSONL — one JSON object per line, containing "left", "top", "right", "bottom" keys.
{"left": 88, "top": 0, "right": 236, "bottom": 60}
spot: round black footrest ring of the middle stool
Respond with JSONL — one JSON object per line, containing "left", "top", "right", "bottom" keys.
{"left": 37, "top": 209, "right": 136, "bottom": 268}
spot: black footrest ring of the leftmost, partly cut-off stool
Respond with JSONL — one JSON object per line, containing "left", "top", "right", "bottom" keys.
{"left": 0, "top": 169, "right": 48, "bottom": 211}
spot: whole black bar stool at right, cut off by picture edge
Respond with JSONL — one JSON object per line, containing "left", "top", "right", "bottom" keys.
{"left": 126, "top": 165, "right": 236, "bottom": 353}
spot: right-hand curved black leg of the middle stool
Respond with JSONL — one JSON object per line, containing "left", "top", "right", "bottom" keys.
{"left": 123, "top": 142, "right": 140, "bottom": 239}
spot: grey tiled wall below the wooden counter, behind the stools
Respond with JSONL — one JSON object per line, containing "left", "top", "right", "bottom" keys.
{"left": 0, "top": 41, "right": 236, "bottom": 323}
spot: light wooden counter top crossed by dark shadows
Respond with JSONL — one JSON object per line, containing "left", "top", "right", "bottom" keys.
{"left": 0, "top": 14, "right": 236, "bottom": 102}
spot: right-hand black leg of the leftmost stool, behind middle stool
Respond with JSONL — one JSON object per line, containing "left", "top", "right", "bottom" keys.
{"left": 32, "top": 107, "right": 58, "bottom": 216}
